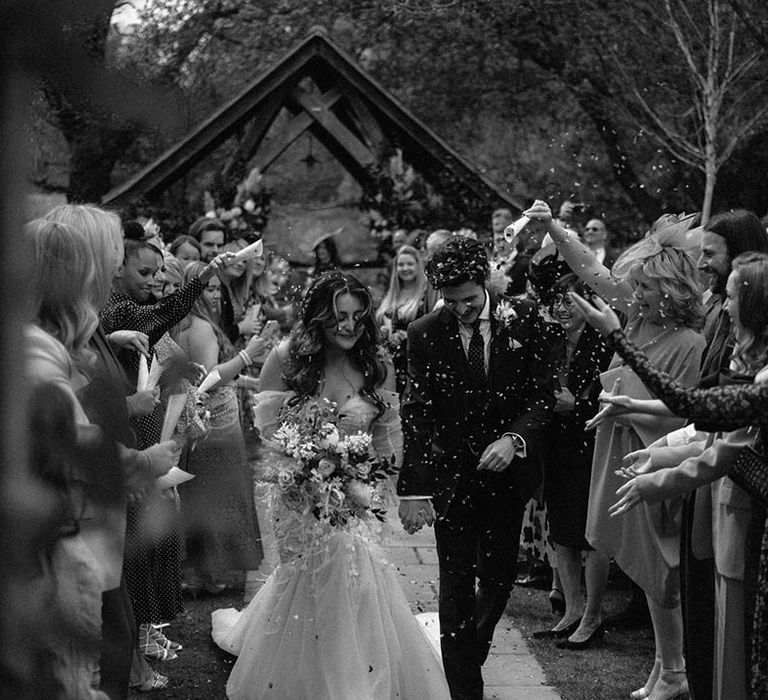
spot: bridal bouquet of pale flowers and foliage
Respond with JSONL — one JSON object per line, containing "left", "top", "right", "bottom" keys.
{"left": 272, "top": 401, "right": 396, "bottom": 527}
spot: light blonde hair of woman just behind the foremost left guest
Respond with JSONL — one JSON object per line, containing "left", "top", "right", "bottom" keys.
{"left": 43, "top": 204, "right": 124, "bottom": 311}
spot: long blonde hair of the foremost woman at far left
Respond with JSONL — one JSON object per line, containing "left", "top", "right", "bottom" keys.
{"left": 24, "top": 219, "right": 99, "bottom": 360}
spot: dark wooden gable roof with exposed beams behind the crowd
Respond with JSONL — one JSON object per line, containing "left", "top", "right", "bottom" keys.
{"left": 102, "top": 28, "right": 522, "bottom": 210}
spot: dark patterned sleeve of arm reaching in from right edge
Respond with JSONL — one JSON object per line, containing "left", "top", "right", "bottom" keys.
{"left": 609, "top": 331, "right": 768, "bottom": 432}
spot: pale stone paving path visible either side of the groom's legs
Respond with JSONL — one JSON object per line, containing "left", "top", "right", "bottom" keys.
{"left": 387, "top": 515, "right": 560, "bottom": 700}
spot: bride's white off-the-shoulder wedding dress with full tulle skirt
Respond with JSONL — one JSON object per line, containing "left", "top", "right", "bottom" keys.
{"left": 212, "top": 391, "right": 449, "bottom": 700}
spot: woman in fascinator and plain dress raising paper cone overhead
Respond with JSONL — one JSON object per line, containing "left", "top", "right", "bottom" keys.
{"left": 525, "top": 200, "right": 704, "bottom": 697}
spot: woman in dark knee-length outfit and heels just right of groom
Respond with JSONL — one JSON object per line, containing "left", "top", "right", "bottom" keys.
{"left": 534, "top": 273, "right": 611, "bottom": 639}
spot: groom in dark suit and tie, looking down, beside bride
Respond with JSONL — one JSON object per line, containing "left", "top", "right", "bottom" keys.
{"left": 397, "top": 236, "right": 555, "bottom": 700}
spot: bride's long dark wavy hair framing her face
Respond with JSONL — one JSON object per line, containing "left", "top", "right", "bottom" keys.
{"left": 283, "top": 271, "right": 387, "bottom": 411}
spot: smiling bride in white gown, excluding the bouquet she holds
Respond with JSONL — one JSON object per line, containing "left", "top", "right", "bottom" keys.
{"left": 212, "top": 272, "right": 449, "bottom": 700}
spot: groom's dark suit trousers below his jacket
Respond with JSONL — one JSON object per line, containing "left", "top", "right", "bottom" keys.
{"left": 435, "top": 473, "right": 530, "bottom": 700}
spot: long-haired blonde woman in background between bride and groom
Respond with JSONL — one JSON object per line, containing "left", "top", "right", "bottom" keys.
{"left": 376, "top": 246, "right": 428, "bottom": 396}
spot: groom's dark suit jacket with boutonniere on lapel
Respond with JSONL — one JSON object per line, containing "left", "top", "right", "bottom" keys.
{"left": 397, "top": 299, "right": 555, "bottom": 516}
